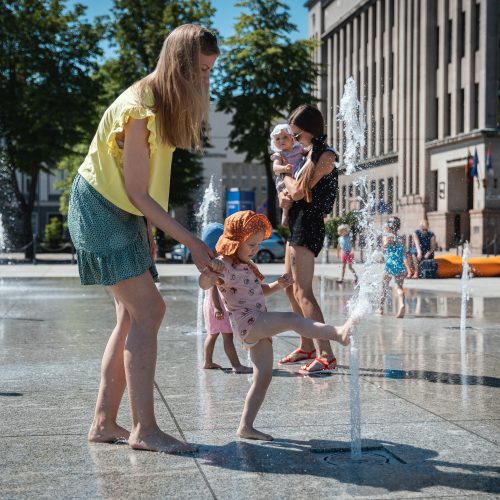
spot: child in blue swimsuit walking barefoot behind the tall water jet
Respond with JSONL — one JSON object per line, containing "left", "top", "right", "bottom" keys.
{"left": 378, "top": 217, "right": 406, "bottom": 318}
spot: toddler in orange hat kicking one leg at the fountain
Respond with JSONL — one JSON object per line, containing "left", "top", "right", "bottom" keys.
{"left": 199, "top": 210, "right": 353, "bottom": 441}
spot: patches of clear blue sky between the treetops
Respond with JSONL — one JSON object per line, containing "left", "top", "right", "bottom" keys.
{"left": 67, "top": 0, "right": 307, "bottom": 50}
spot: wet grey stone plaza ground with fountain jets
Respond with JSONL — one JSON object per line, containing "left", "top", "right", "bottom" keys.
{"left": 0, "top": 264, "right": 500, "bottom": 499}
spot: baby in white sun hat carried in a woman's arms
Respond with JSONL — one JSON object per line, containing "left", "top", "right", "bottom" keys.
{"left": 271, "top": 123, "right": 307, "bottom": 227}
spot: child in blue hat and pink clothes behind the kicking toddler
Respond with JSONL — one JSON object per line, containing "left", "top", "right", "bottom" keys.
{"left": 201, "top": 222, "right": 252, "bottom": 373}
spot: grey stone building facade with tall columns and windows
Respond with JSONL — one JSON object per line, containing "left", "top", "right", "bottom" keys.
{"left": 306, "top": 0, "right": 500, "bottom": 252}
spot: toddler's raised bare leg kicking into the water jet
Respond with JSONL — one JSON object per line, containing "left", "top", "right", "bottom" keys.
{"left": 245, "top": 312, "right": 353, "bottom": 345}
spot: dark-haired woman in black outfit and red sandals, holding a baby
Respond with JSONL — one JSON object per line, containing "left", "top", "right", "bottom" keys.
{"left": 280, "top": 104, "right": 338, "bottom": 374}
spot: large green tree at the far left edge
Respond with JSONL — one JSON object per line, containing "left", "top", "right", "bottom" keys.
{"left": 0, "top": 0, "right": 103, "bottom": 247}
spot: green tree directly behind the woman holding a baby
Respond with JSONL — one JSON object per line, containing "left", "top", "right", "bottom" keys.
{"left": 217, "top": 0, "right": 319, "bottom": 226}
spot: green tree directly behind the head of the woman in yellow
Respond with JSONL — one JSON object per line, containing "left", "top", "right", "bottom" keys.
{"left": 101, "top": 0, "right": 215, "bottom": 206}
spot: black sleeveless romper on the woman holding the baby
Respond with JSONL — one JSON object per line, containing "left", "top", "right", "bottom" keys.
{"left": 288, "top": 168, "right": 338, "bottom": 257}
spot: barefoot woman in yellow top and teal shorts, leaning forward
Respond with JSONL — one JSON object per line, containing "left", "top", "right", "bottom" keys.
{"left": 68, "top": 25, "right": 219, "bottom": 453}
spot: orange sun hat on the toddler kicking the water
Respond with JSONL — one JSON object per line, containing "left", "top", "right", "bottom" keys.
{"left": 215, "top": 210, "right": 273, "bottom": 256}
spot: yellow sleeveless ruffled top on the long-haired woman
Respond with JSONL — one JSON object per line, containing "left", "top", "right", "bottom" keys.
{"left": 78, "top": 83, "right": 175, "bottom": 215}
